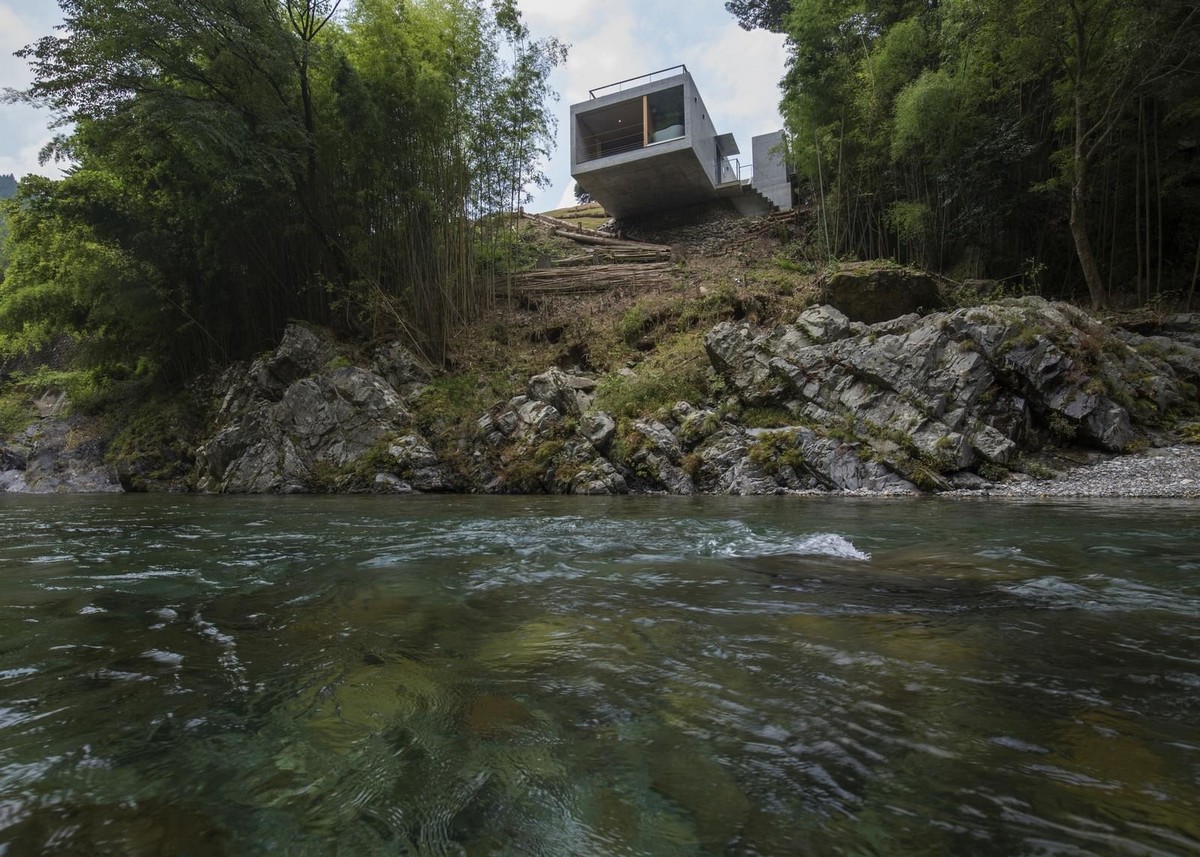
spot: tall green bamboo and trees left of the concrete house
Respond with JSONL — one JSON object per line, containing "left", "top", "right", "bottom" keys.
{"left": 0, "top": 0, "right": 565, "bottom": 378}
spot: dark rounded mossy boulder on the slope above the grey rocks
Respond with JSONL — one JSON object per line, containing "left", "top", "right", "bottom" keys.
{"left": 824, "top": 263, "right": 942, "bottom": 324}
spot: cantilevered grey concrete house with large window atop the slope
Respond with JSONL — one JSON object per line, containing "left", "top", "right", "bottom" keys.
{"left": 571, "top": 66, "right": 792, "bottom": 217}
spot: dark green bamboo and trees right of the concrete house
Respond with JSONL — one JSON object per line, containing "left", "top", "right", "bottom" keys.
{"left": 726, "top": 0, "right": 1200, "bottom": 307}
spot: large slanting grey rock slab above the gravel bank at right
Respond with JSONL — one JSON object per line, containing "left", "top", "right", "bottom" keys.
{"left": 706, "top": 298, "right": 1196, "bottom": 489}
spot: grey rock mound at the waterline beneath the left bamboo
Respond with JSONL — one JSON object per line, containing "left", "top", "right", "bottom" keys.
{"left": 197, "top": 325, "right": 451, "bottom": 493}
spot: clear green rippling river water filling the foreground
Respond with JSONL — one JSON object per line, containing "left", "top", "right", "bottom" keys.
{"left": 0, "top": 496, "right": 1200, "bottom": 856}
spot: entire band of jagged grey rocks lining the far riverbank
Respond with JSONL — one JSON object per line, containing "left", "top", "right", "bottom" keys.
{"left": 9, "top": 298, "right": 1200, "bottom": 495}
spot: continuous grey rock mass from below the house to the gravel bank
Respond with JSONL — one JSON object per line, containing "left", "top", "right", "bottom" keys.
{"left": 372, "top": 299, "right": 1200, "bottom": 495}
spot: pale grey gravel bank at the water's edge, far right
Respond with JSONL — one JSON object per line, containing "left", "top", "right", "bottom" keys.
{"left": 950, "top": 445, "right": 1200, "bottom": 498}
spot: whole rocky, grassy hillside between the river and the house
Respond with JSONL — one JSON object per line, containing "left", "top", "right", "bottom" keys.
{"left": 0, "top": 200, "right": 1200, "bottom": 493}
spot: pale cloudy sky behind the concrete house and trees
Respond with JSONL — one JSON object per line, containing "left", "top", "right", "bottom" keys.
{"left": 0, "top": 0, "right": 786, "bottom": 211}
